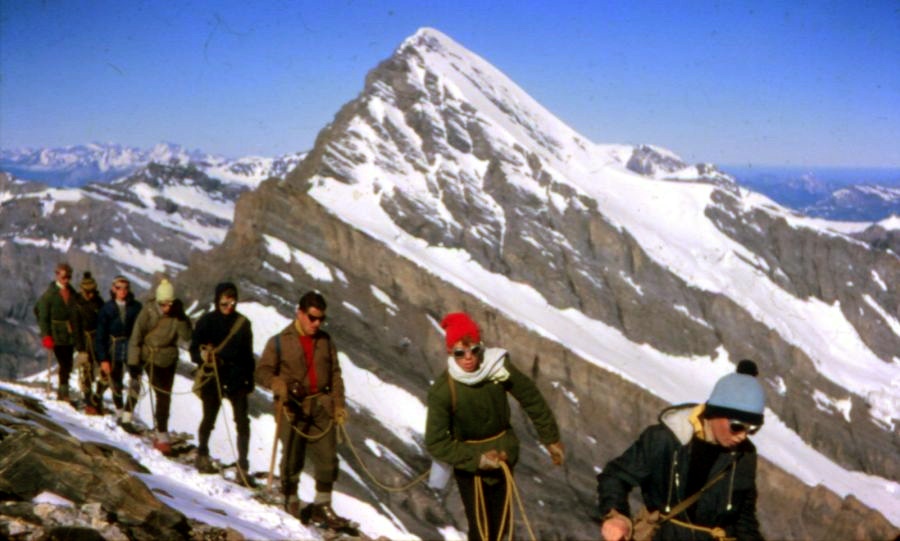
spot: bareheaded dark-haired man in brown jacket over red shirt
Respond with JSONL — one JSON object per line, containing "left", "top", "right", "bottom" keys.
{"left": 256, "top": 291, "right": 349, "bottom": 530}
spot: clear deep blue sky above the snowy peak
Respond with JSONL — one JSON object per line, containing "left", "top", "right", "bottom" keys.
{"left": 0, "top": 0, "right": 900, "bottom": 167}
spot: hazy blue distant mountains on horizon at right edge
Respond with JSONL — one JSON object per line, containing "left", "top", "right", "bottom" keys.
{"left": 721, "top": 166, "right": 900, "bottom": 222}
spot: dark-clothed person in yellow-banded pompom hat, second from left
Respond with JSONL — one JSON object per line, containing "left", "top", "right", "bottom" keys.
{"left": 75, "top": 271, "right": 103, "bottom": 415}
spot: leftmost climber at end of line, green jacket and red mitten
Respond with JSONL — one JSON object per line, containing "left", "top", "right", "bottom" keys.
{"left": 36, "top": 262, "right": 84, "bottom": 401}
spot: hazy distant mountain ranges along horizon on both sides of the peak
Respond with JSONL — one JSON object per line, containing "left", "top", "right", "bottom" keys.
{"left": 0, "top": 143, "right": 900, "bottom": 222}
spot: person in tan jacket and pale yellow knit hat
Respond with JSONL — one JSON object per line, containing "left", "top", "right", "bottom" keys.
{"left": 122, "top": 278, "right": 192, "bottom": 455}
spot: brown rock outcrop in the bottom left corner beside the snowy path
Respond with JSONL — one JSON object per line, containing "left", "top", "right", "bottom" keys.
{"left": 0, "top": 390, "right": 189, "bottom": 540}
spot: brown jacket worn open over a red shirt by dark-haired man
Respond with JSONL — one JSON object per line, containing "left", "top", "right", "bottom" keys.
{"left": 256, "top": 321, "right": 345, "bottom": 415}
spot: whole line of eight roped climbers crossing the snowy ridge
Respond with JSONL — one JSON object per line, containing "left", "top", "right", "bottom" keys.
{"left": 35, "top": 263, "right": 765, "bottom": 541}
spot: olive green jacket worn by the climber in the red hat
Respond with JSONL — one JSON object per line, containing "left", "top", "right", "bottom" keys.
{"left": 425, "top": 349, "right": 559, "bottom": 473}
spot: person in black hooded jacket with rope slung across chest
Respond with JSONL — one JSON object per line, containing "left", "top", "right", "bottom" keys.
{"left": 190, "top": 282, "right": 256, "bottom": 487}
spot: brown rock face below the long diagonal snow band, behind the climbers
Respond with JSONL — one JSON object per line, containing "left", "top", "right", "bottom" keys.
{"left": 180, "top": 181, "right": 893, "bottom": 539}
